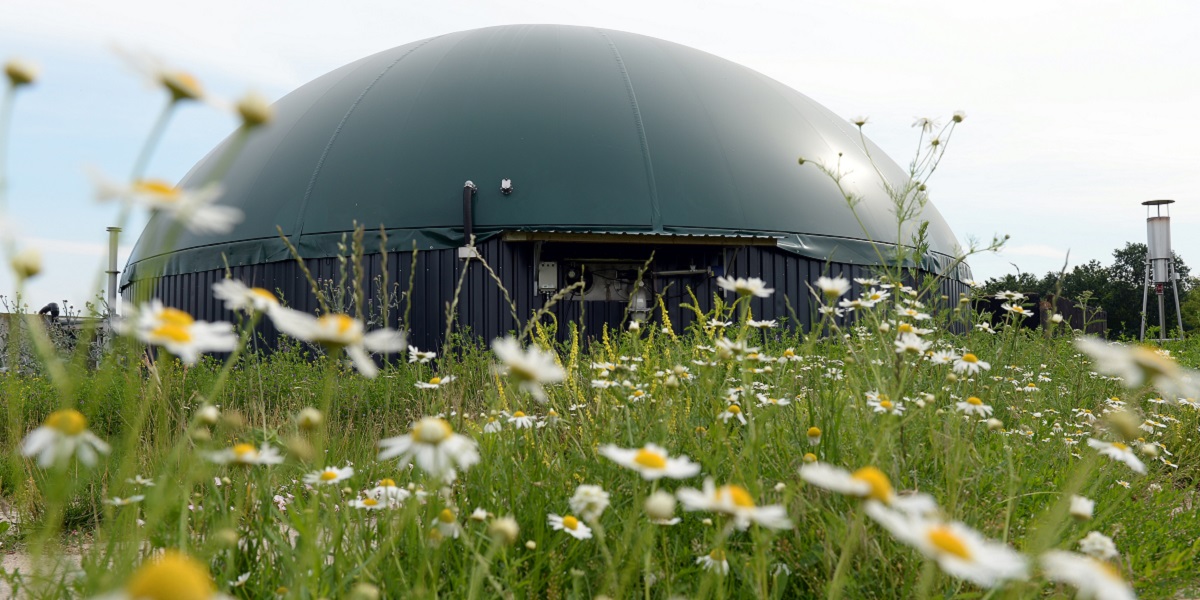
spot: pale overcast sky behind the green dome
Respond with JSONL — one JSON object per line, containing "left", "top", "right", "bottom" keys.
{"left": 0, "top": 0, "right": 1200, "bottom": 310}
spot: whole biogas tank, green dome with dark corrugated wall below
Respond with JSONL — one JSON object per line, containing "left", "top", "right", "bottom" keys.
{"left": 121, "top": 25, "right": 970, "bottom": 347}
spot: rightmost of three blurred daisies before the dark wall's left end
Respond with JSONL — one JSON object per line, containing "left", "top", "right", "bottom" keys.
{"left": 270, "top": 307, "right": 407, "bottom": 379}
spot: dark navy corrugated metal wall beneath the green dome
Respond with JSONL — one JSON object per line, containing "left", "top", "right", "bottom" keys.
{"left": 122, "top": 238, "right": 967, "bottom": 348}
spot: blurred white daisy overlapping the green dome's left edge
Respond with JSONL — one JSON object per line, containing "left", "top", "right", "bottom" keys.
{"left": 91, "top": 172, "right": 244, "bottom": 234}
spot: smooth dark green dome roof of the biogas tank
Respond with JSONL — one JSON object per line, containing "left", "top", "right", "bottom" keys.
{"left": 125, "top": 25, "right": 958, "bottom": 282}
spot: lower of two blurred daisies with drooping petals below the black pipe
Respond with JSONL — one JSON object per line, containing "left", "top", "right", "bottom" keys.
{"left": 378, "top": 416, "right": 479, "bottom": 484}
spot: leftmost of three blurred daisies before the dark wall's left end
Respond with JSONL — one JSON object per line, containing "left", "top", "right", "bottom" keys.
{"left": 113, "top": 299, "right": 238, "bottom": 366}
